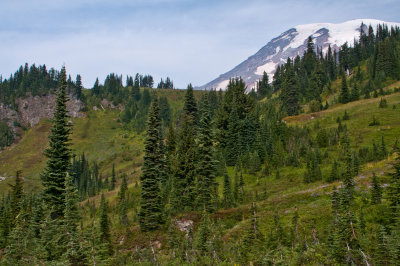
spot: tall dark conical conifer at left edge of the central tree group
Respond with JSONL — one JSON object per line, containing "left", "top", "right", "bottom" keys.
{"left": 139, "top": 98, "right": 163, "bottom": 231}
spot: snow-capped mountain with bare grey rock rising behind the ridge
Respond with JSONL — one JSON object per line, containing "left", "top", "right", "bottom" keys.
{"left": 199, "top": 19, "right": 400, "bottom": 89}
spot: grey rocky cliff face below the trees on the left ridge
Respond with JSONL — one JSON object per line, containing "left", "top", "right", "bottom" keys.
{"left": 0, "top": 94, "right": 84, "bottom": 138}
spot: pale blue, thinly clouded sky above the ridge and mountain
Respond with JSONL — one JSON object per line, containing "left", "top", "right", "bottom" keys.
{"left": 0, "top": 0, "right": 400, "bottom": 88}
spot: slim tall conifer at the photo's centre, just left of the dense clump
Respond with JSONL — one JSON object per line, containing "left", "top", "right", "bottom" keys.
{"left": 196, "top": 96, "right": 217, "bottom": 212}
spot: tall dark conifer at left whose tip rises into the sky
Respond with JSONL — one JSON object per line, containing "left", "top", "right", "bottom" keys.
{"left": 41, "top": 67, "right": 71, "bottom": 218}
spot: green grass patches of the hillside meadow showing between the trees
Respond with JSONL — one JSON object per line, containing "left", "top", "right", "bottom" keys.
{"left": 0, "top": 82, "right": 400, "bottom": 258}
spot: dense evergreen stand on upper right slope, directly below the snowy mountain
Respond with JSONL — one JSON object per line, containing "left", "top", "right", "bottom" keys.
{"left": 272, "top": 24, "right": 400, "bottom": 115}
